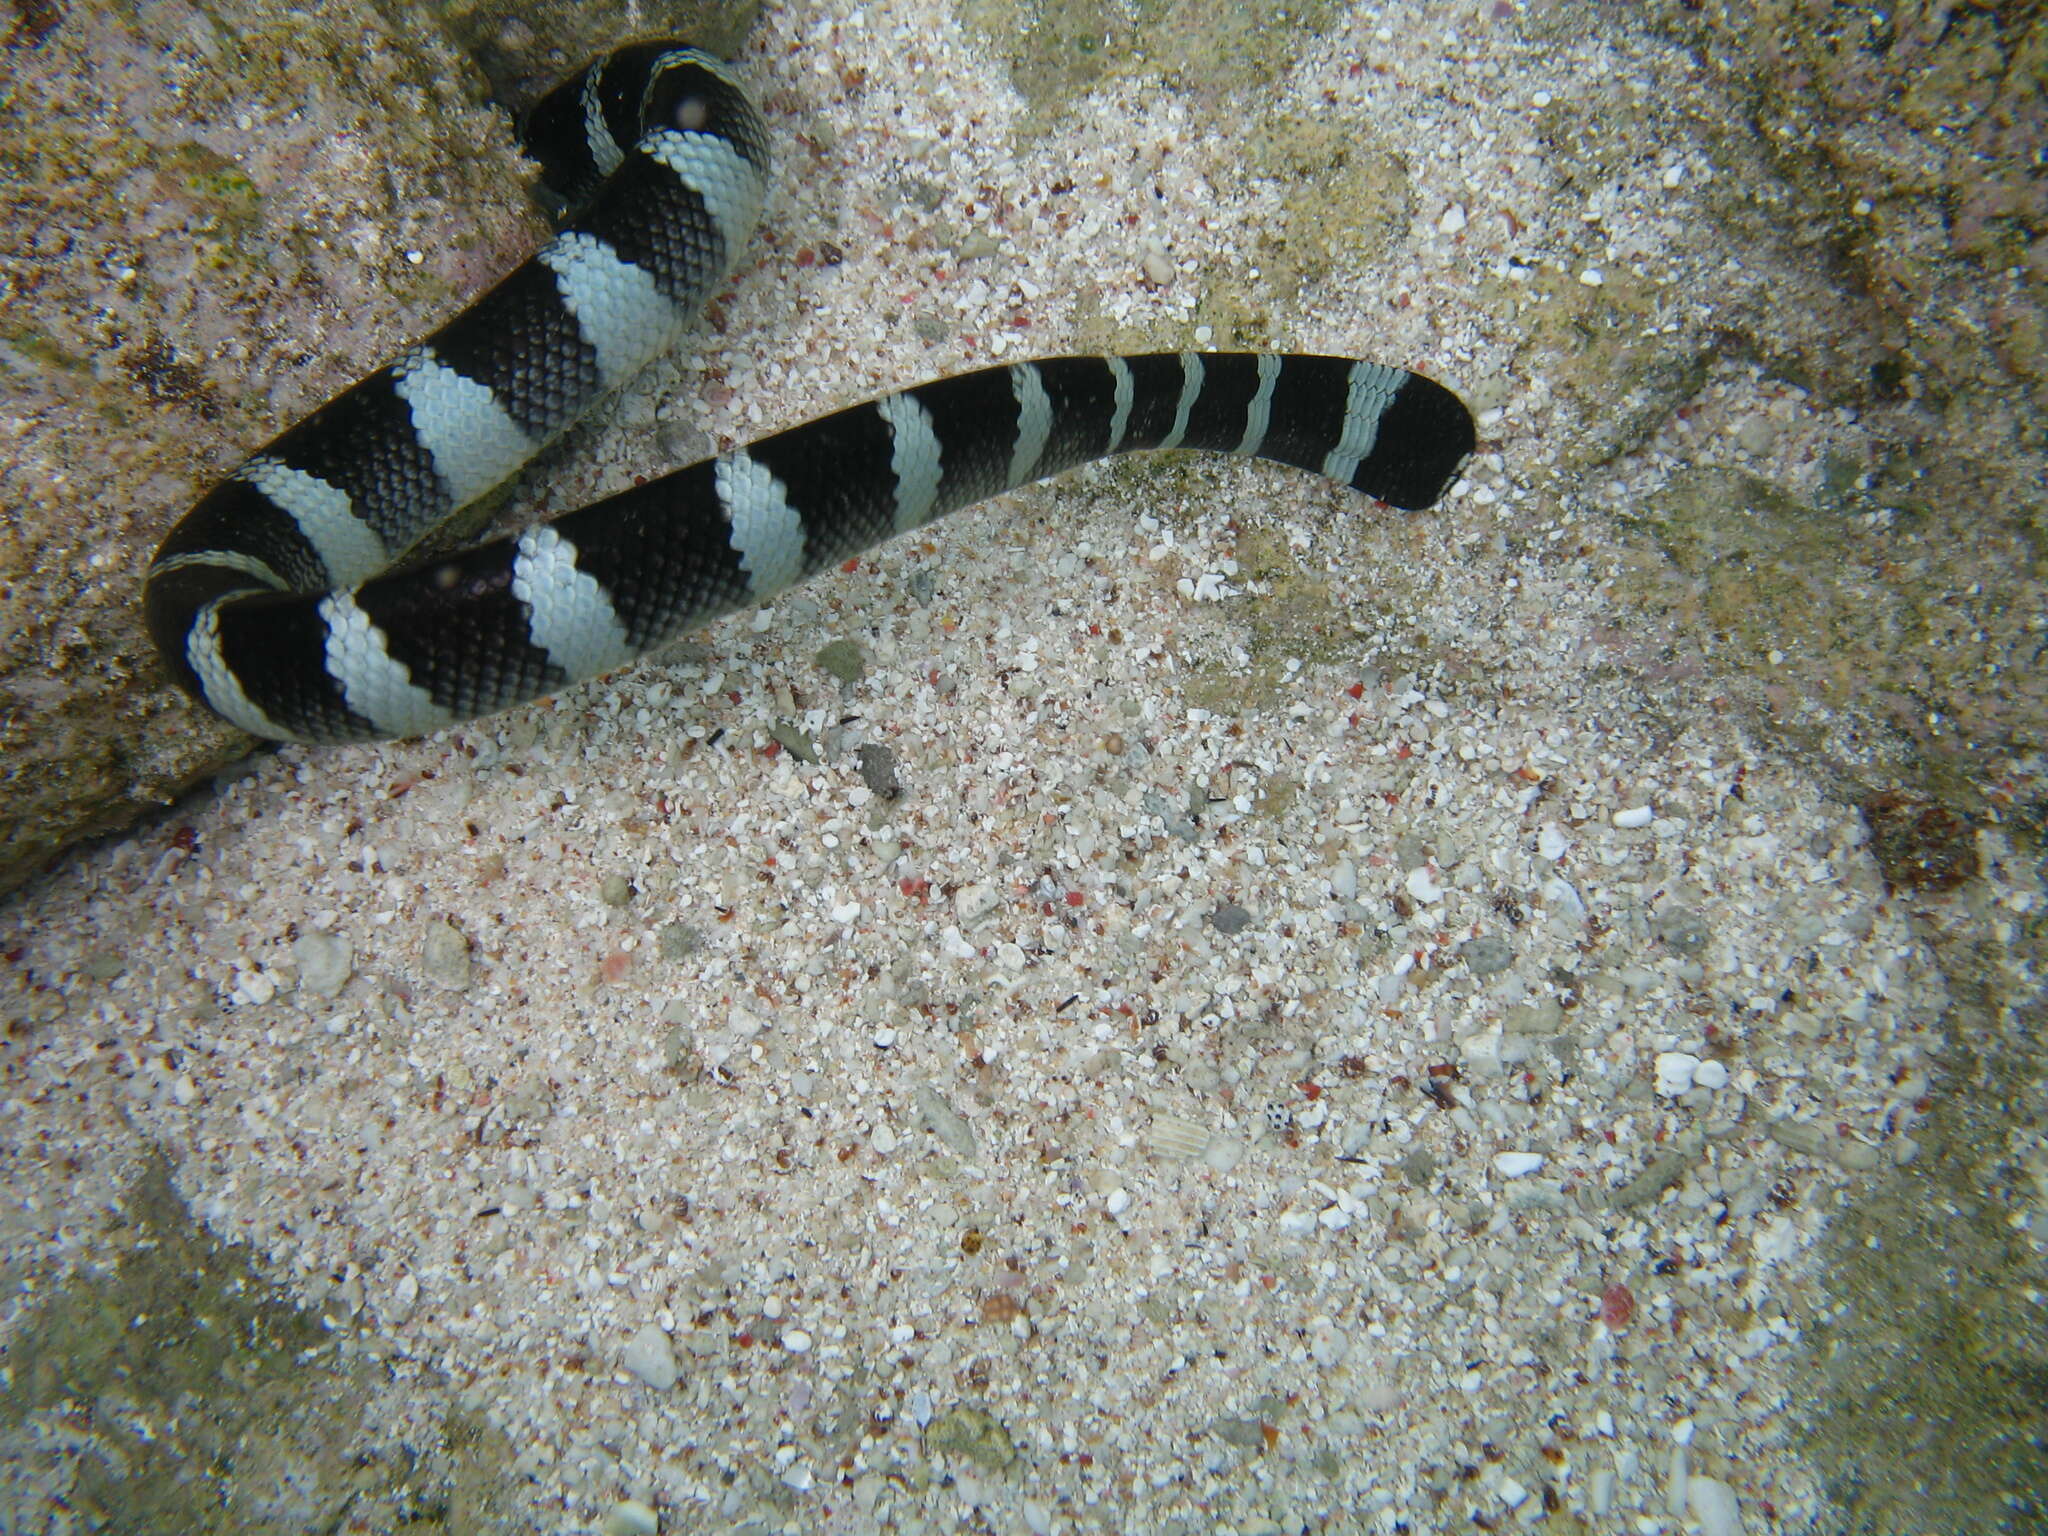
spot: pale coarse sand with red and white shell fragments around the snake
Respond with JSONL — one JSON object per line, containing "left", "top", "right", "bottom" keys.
{"left": 0, "top": 2, "right": 2030, "bottom": 1532}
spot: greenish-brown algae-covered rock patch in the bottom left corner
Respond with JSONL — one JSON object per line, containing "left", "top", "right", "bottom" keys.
{"left": 0, "top": 1163, "right": 520, "bottom": 1536}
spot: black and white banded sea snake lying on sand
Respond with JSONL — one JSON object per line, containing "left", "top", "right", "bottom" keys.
{"left": 145, "top": 41, "right": 1475, "bottom": 741}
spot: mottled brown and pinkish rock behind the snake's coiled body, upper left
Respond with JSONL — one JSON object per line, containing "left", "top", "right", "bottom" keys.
{"left": 0, "top": 0, "right": 752, "bottom": 889}
